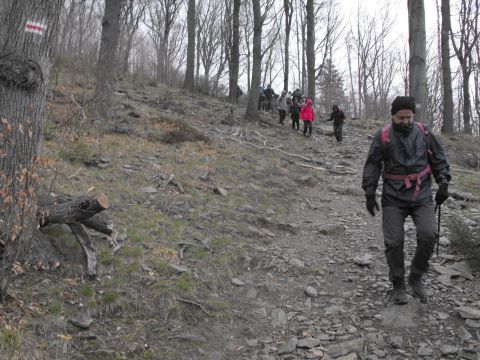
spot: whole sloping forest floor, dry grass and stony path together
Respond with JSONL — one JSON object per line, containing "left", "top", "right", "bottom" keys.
{"left": 0, "top": 87, "right": 480, "bottom": 360}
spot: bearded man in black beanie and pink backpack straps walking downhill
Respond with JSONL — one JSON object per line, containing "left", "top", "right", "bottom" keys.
{"left": 362, "top": 96, "right": 450, "bottom": 304}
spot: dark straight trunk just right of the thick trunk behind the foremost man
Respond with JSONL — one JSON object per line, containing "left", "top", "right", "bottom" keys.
{"left": 441, "top": 0, "right": 453, "bottom": 135}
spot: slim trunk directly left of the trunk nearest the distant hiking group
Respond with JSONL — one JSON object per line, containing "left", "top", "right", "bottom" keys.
{"left": 228, "top": 0, "right": 242, "bottom": 104}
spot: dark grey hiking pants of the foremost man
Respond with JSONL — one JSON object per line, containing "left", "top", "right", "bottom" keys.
{"left": 382, "top": 203, "right": 435, "bottom": 281}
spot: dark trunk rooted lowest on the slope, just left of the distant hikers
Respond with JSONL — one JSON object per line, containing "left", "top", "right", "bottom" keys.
{"left": 245, "top": 0, "right": 262, "bottom": 121}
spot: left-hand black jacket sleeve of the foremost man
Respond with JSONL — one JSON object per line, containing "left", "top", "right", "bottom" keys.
{"left": 362, "top": 130, "right": 383, "bottom": 195}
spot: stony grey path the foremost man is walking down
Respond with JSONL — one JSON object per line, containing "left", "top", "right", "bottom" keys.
{"left": 193, "top": 113, "right": 480, "bottom": 360}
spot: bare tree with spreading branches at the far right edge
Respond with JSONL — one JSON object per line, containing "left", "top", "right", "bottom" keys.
{"left": 450, "top": 0, "right": 479, "bottom": 134}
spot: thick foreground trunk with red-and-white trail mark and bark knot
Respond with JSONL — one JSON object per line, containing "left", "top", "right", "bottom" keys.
{"left": 0, "top": 0, "right": 63, "bottom": 300}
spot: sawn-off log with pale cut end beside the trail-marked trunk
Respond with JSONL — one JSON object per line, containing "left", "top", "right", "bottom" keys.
{"left": 37, "top": 194, "right": 110, "bottom": 227}
